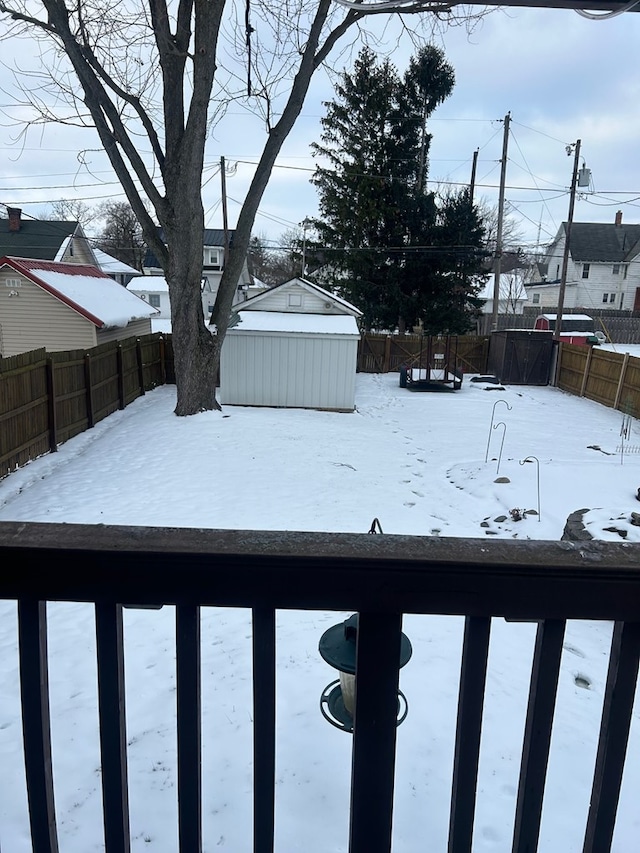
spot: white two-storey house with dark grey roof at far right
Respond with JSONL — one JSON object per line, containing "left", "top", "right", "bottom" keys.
{"left": 526, "top": 211, "right": 640, "bottom": 310}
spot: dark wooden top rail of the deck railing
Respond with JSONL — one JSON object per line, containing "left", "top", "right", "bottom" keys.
{"left": 0, "top": 522, "right": 640, "bottom": 621}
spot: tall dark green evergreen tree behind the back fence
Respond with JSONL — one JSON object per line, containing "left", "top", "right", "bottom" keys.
{"left": 313, "top": 46, "right": 482, "bottom": 332}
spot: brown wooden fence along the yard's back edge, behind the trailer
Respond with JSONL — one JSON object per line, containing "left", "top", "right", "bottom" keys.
{"left": 358, "top": 335, "right": 489, "bottom": 373}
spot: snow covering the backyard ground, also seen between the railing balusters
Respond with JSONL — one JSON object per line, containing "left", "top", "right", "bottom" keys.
{"left": 0, "top": 374, "right": 640, "bottom": 853}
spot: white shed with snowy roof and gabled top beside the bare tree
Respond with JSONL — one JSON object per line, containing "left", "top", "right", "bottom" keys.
{"left": 220, "top": 278, "right": 361, "bottom": 412}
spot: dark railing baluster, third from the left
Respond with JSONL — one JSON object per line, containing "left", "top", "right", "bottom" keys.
{"left": 176, "top": 605, "right": 202, "bottom": 853}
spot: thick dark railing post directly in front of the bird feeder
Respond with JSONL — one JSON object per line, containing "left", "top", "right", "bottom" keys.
{"left": 349, "top": 612, "right": 402, "bottom": 853}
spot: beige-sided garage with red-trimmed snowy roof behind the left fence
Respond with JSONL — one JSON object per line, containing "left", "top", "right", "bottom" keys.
{"left": 0, "top": 257, "right": 157, "bottom": 357}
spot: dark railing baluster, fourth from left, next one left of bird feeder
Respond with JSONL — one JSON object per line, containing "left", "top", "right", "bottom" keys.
{"left": 252, "top": 607, "right": 276, "bottom": 853}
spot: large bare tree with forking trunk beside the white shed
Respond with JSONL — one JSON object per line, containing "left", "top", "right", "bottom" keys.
{"left": 0, "top": 0, "right": 490, "bottom": 415}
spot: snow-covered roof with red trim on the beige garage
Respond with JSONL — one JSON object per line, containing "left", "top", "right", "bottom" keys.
{"left": 0, "top": 257, "right": 158, "bottom": 329}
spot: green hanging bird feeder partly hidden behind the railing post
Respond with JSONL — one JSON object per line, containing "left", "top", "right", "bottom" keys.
{"left": 318, "top": 613, "right": 412, "bottom": 732}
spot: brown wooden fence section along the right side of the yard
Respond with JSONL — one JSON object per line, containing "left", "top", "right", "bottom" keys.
{"left": 557, "top": 344, "right": 640, "bottom": 417}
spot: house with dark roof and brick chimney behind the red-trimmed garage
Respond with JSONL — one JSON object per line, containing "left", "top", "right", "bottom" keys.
{"left": 0, "top": 207, "right": 96, "bottom": 264}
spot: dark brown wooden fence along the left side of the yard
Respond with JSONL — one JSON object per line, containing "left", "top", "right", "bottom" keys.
{"left": 0, "top": 334, "right": 173, "bottom": 477}
